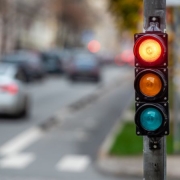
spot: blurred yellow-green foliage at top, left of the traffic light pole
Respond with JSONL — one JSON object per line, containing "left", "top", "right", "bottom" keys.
{"left": 109, "top": 0, "right": 143, "bottom": 32}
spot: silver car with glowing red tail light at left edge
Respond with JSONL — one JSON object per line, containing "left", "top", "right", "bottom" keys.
{"left": 0, "top": 65, "right": 30, "bottom": 116}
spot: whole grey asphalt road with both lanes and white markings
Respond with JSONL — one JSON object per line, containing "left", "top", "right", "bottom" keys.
{"left": 0, "top": 67, "right": 138, "bottom": 180}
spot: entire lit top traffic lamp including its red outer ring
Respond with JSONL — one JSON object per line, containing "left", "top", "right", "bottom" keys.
{"left": 134, "top": 34, "right": 166, "bottom": 66}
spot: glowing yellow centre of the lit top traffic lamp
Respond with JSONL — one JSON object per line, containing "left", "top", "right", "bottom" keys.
{"left": 139, "top": 39, "right": 162, "bottom": 62}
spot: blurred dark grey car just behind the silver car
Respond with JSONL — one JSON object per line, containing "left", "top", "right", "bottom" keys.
{"left": 1, "top": 51, "right": 45, "bottom": 82}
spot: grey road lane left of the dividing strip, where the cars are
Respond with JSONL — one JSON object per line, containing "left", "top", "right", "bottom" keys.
{"left": 0, "top": 67, "right": 131, "bottom": 144}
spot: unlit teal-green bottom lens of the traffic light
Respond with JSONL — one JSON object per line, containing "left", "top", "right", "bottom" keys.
{"left": 140, "top": 108, "right": 163, "bottom": 131}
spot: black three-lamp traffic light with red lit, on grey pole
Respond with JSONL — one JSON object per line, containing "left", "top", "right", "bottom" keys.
{"left": 134, "top": 31, "right": 169, "bottom": 138}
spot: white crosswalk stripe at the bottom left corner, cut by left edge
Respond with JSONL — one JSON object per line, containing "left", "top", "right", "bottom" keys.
{"left": 0, "top": 153, "right": 35, "bottom": 169}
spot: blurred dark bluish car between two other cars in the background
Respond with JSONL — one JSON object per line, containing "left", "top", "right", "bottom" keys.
{"left": 41, "top": 49, "right": 71, "bottom": 74}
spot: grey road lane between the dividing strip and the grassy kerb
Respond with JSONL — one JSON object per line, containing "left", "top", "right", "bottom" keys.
{"left": 0, "top": 65, "right": 135, "bottom": 180}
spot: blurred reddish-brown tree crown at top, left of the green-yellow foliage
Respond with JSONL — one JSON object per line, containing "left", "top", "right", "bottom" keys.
{"left": 50, "top": 0, "right": 96, "bottom": 46}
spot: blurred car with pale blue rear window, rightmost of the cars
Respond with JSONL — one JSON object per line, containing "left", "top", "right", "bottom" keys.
{"left": 66, "top": 52, "right": 101, "bottom": 81}
